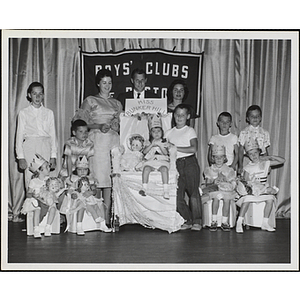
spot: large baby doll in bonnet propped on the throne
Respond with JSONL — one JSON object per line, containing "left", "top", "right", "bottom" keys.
{"left": 120, "top": 134, "right": 145, "bottom": 171}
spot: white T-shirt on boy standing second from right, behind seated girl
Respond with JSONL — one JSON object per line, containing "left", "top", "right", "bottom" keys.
{"left": 208, "top": 132, "right": 238, "bottom": 166}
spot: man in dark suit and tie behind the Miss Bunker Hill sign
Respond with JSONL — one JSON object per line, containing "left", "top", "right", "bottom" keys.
{"left": 117, "top": 69, "right": 157, "bottom": 109}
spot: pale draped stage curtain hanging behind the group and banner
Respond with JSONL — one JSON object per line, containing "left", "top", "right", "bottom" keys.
{"left": 8, "top": 38, "right": 291, "bottom": 217}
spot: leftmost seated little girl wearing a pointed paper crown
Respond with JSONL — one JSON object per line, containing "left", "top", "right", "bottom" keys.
{"left": 21, "top": 154, "right": 59, "bottom": 238}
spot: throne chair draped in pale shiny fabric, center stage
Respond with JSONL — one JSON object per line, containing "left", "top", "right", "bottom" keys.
{"left": 111, "top": 114, "right": 184, "bottom": 233}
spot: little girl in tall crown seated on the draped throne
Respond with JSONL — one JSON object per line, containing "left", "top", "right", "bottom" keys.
{"left": 139, "top": 114, "right": 170, "bottom": 199}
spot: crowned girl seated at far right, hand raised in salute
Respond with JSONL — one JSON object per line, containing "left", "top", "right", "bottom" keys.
{"left": 236, "top": 139, "right": 285, "bottom": 233}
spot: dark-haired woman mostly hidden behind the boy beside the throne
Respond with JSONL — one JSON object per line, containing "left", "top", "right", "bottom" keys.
{"left": 167, "top": 79, "right": 198, "bottom": 127}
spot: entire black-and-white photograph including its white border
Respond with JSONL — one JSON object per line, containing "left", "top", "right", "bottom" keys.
{"left": 1, "top": 30, "right": 299, "bottom": 271}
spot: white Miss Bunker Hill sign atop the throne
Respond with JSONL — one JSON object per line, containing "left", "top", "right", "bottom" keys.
{"left": 125, "top": 98, "right": 168, "bottom": 117}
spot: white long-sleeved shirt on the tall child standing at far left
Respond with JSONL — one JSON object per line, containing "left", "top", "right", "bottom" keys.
{"left": 16, "top": 105, "right": 57, "bottom": 159}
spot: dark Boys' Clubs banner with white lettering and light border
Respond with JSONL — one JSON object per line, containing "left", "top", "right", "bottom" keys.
{"left": 81, "top": 49, "right": 203, "bottom": 115}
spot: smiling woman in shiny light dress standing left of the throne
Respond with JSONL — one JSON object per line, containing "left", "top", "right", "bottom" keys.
{"left": 73, "top": 69, "right": 122, "bottom": 225}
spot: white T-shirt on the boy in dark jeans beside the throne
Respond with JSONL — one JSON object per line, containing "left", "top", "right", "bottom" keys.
{"left": 165, "top": 125, "right": 197, "bottom": 158}
